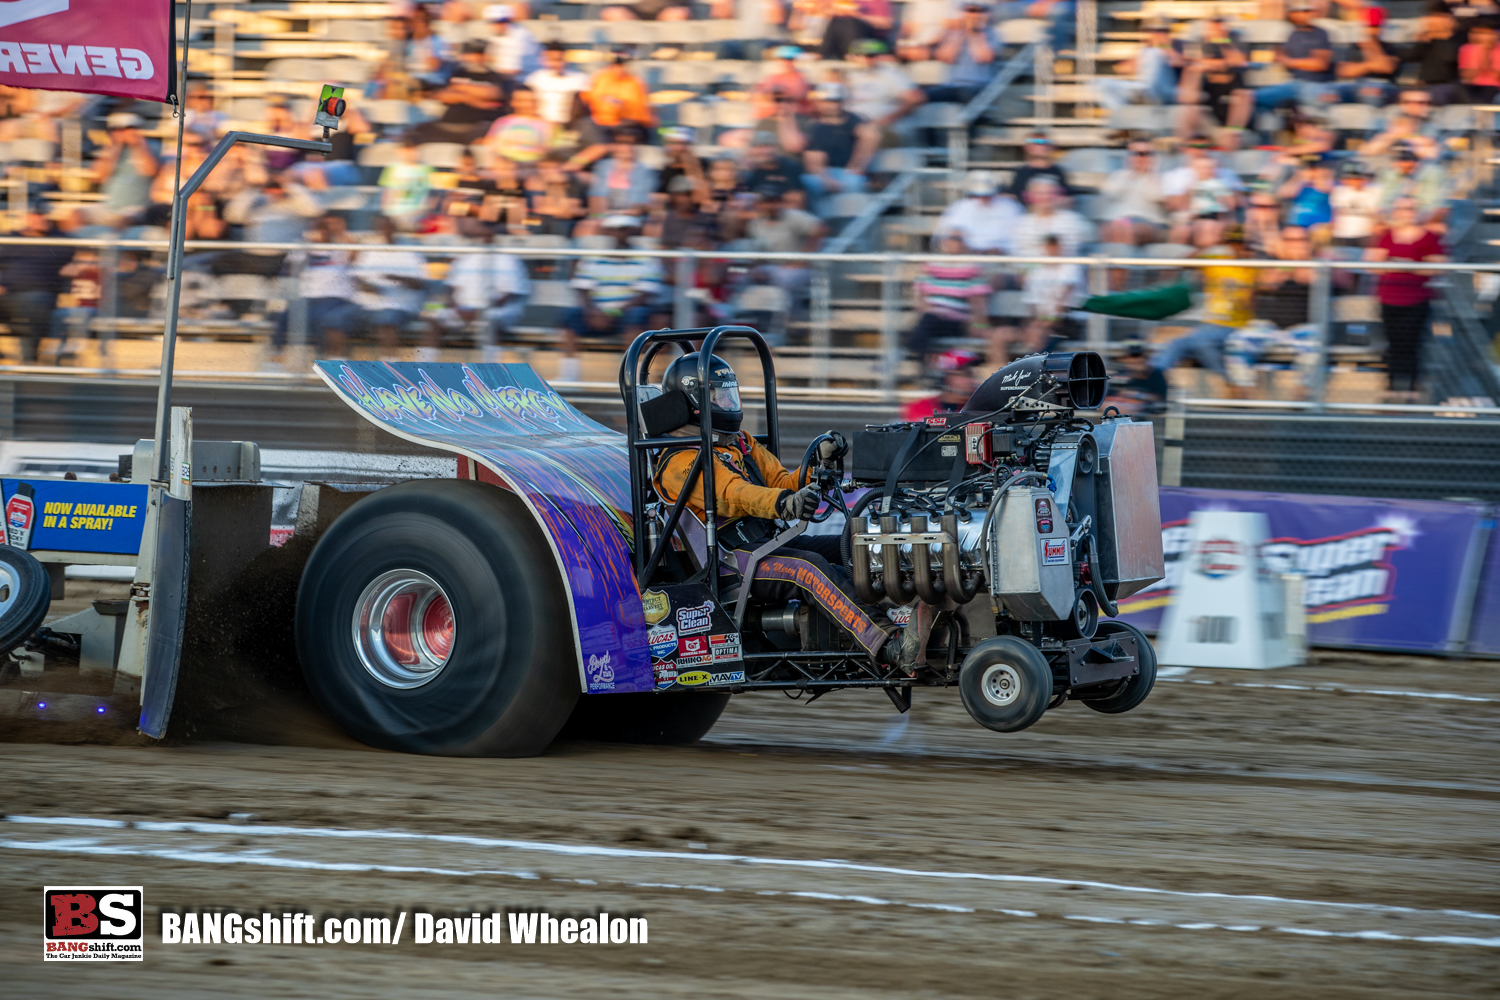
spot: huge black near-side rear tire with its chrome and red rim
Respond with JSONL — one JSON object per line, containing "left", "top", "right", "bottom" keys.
{"left": 297, "top": 480, "right": 579, "bottom": 757}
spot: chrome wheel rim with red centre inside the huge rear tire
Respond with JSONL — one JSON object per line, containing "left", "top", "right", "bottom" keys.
{"left": 354, "top": 570, "right": 456, "bottom": 690}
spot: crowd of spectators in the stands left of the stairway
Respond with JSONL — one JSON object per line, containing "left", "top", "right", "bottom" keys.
{"left": 0, "top": 0, "right": 1020, "bottom": 371}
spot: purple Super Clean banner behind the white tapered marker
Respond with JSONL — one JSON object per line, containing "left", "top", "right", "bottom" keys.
{"left": 1121, "top": 487, "right": 1500, "bottom": 652}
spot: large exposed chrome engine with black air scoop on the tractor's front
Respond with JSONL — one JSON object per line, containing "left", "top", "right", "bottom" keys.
{"left": 846, "top": 352, "right": 1164, "bottom": 639}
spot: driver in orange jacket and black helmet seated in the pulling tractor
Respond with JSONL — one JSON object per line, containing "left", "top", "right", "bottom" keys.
{"left": 654, "top": 351, "right": 926, "bottom": 669}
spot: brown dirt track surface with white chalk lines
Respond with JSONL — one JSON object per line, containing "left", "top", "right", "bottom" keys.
{"left": 0, "top": 657, "right": 1500, "bottom": 1000}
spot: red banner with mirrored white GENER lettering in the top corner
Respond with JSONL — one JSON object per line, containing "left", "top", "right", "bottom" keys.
{"left": 0, "top": 0, "right": 173, "bottom": 100}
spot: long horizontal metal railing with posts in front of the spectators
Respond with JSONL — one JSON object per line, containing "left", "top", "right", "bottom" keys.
{"left": 0, "top": 237, "right": 1500, "bottom": 409}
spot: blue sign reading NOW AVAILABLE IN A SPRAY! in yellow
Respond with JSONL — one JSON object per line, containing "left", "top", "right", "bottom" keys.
{"left": 0, "top": 480, "right": 150, "bottom": 556}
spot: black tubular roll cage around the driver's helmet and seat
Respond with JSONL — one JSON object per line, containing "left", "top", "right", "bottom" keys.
{"left": 620, "top": 327, "right": 782, "bottom": 600}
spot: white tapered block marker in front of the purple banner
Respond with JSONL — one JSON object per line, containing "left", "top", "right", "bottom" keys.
{"left": 1157, "top": 510, "right": 1299, "bottom": 670}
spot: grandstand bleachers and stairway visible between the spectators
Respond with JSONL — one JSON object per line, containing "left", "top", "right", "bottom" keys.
{"left": 0, "top": 0, "right": 1500, "bottom": 402}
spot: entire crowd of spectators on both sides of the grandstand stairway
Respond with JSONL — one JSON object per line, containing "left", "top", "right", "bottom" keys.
{"left": 0, "top": 0, "right": 1476, "bottom": 399}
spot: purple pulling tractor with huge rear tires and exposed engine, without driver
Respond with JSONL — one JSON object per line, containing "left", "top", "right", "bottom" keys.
{"left": 286, "top": 327, "right": 1163, "bottom": 756}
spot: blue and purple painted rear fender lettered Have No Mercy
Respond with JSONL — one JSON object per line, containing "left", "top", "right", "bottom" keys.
{"left": 317, "top": 361, "right": 656, "bottom": 693}
